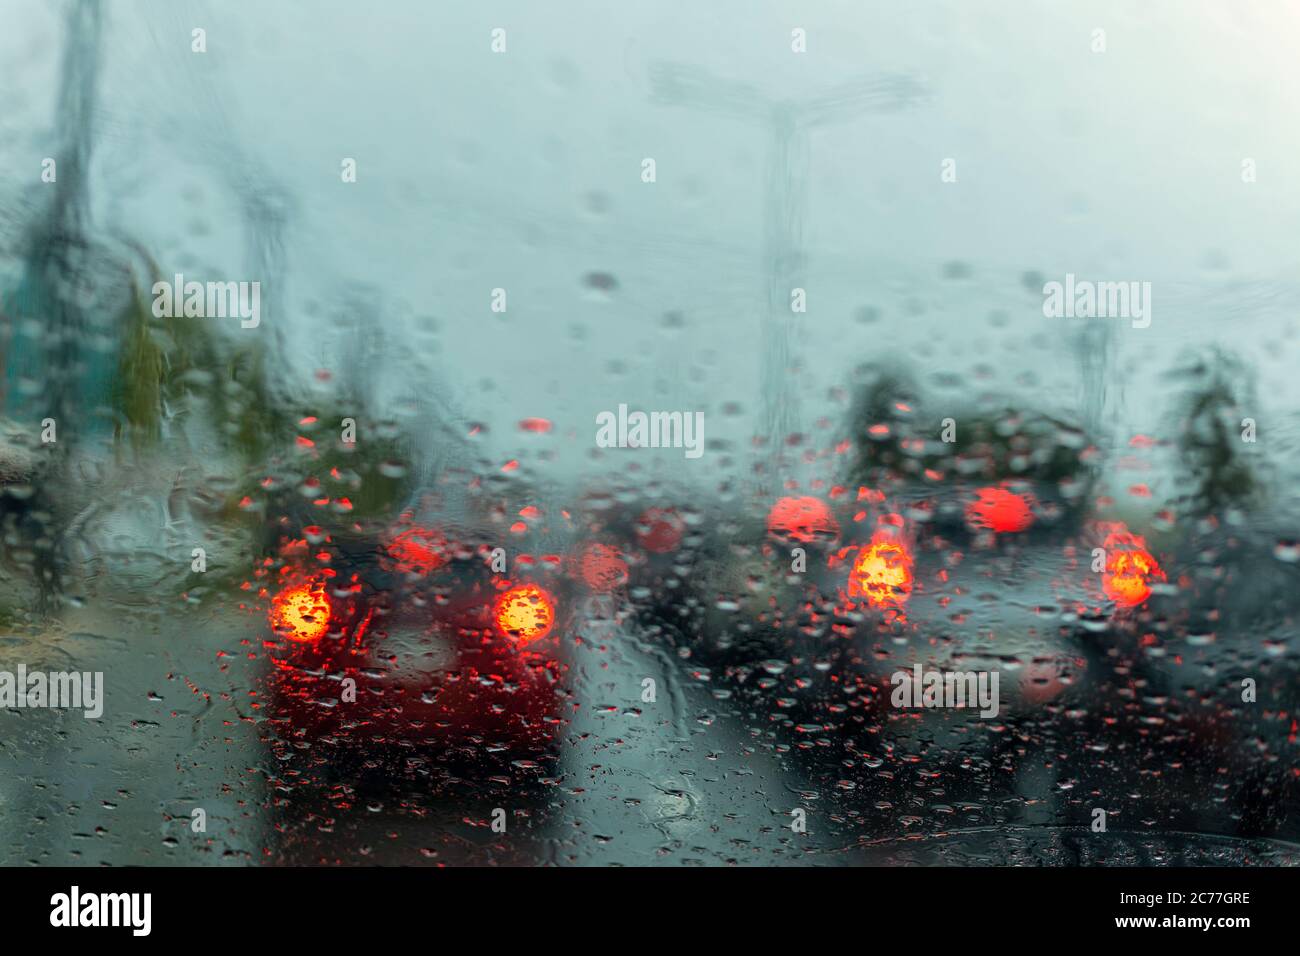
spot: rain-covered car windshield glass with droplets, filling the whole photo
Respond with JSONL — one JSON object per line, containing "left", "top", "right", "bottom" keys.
{"left": 0, "top": 0, "right": 1300, "bottom": 866}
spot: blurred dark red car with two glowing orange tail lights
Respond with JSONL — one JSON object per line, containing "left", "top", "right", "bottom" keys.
{"left": 256, "top": 535, "right": 568, "bottom": 763}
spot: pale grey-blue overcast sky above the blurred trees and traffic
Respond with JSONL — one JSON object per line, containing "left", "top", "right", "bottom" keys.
{"left": 0, "top": 0, "right": 1300, "bottom": 494}
